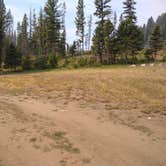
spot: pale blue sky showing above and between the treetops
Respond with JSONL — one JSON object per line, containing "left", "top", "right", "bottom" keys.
{"left": 4, "top": 0, "right": 166, "bottom": 43}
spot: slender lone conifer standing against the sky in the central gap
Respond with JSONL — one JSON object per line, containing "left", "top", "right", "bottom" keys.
{"left": 75, "top": 0, "right": 85, "bottom": 51}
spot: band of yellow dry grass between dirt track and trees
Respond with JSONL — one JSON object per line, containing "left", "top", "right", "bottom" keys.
{"left": 0, "top": 66, "right": 166, "bottom": 112}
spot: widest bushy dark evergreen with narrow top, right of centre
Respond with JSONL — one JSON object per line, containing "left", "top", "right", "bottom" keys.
{"left": 117, "top": 0, "right": 143, "bottom": 62}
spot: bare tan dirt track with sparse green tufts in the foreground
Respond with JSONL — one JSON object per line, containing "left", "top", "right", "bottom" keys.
{"left": 0, "top": 95, "right": 166, "bottom": 166}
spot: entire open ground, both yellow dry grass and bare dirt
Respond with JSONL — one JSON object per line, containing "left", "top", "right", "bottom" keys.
{"left": 0, "top": 66, "right": 166, "bottom": 166}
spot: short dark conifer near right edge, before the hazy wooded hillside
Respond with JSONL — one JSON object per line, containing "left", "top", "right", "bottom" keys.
{"left": 150, "top": 26, "right": 162, "bottom": 56}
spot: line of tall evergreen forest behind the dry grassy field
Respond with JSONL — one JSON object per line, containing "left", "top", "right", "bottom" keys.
{"left": 0, "top": 0, "right": 166, "bottom": 70}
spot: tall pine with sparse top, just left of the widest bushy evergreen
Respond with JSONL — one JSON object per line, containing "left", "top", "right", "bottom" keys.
{"left": 93, "top": 0, "right": 111, "bottom": 63}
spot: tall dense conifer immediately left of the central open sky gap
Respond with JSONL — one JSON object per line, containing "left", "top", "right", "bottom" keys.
{"left": 44, "top": 0, "right": 60, "bottom": 53}
